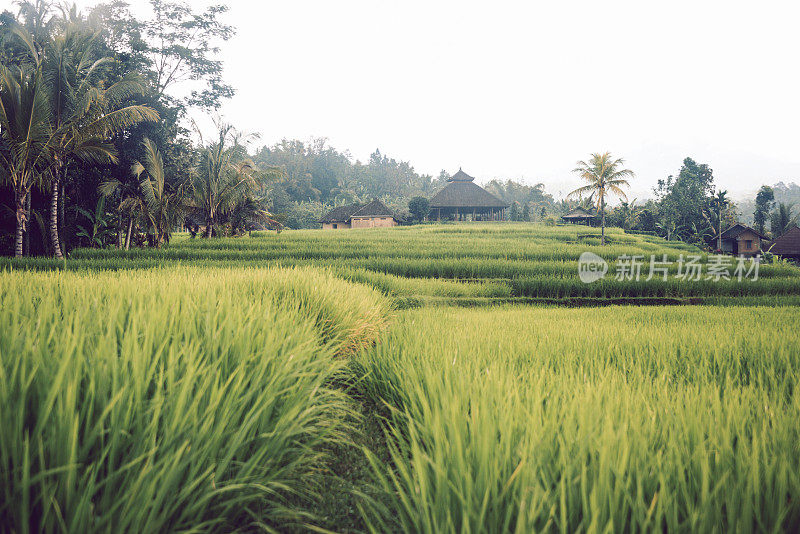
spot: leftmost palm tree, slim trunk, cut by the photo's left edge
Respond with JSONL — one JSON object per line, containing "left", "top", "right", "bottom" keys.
{"left": 0, "top": 64, "right": 52, "bottom": 257}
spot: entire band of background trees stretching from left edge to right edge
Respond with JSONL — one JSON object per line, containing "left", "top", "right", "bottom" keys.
{"left": 0, "top": 0, "right": 800, "bottom": 257}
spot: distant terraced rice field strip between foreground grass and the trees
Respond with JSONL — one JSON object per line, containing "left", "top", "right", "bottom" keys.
{"left": 0, "top": 223, "right": 800, "bottom": 301}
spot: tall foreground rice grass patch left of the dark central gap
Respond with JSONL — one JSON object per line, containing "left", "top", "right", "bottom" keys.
{"left": 0, "top": 268, "right": 388, "bottom": 532}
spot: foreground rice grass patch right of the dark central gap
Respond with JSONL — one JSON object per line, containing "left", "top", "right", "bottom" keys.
{"left": 353, "top": 307, "right": 800, "bottom": 532}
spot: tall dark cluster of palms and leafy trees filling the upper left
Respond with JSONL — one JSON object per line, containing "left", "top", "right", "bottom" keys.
{"left": 0, "top": 0, "right": 249, "bottom": 256}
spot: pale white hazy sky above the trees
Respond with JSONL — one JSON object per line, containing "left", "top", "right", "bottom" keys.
{"left": 72, "top": 0, "right": 800, "bottom": 198}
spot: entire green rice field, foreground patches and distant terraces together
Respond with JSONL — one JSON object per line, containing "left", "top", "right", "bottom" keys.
{"left": 0, "top": 224, "right": 800, "bottom": 533}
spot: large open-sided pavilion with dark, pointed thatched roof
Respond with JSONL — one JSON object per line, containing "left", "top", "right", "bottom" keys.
{"left": 430, "top": 169, "right": 508, "bottom": 221}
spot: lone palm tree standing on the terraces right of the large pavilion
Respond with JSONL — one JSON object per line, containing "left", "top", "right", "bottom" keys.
{"left": 567, "top": 152, "right": 634, "bottom": 245}
